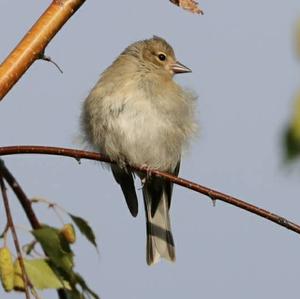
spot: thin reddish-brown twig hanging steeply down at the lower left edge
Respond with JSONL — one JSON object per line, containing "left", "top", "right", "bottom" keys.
{"left": 0, "top": 174, "right": 30, "bottom": 299}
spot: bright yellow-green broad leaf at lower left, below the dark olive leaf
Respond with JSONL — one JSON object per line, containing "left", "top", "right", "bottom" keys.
{"left": 24, "top": 259, "right": 70, "bottom": 289}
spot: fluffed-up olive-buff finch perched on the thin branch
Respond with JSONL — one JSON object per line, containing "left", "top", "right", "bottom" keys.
{"left": 81, "top": 36, "right": 198, "bottom": 265}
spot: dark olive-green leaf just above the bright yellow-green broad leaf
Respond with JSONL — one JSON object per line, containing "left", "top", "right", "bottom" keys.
{"left": 32, "top": 226, "right": 73, "bottom": 272}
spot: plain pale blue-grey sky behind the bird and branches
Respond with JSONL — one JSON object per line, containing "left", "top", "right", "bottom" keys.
{"left": 0, "top": 0, "right": 300, "bottom": 299}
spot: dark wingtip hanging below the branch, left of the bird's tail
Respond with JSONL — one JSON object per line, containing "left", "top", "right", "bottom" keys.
{"left": 111, "top": 165, "right": 138, "bottom": 217}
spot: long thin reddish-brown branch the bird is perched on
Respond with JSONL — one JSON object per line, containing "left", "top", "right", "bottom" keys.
{"left": 0, "top": 146, "right": 300, "bottom": 234}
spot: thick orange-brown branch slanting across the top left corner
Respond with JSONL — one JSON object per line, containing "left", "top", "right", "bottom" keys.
{"left": 0, "top": 0, "right": 85, "bottom": 101}
